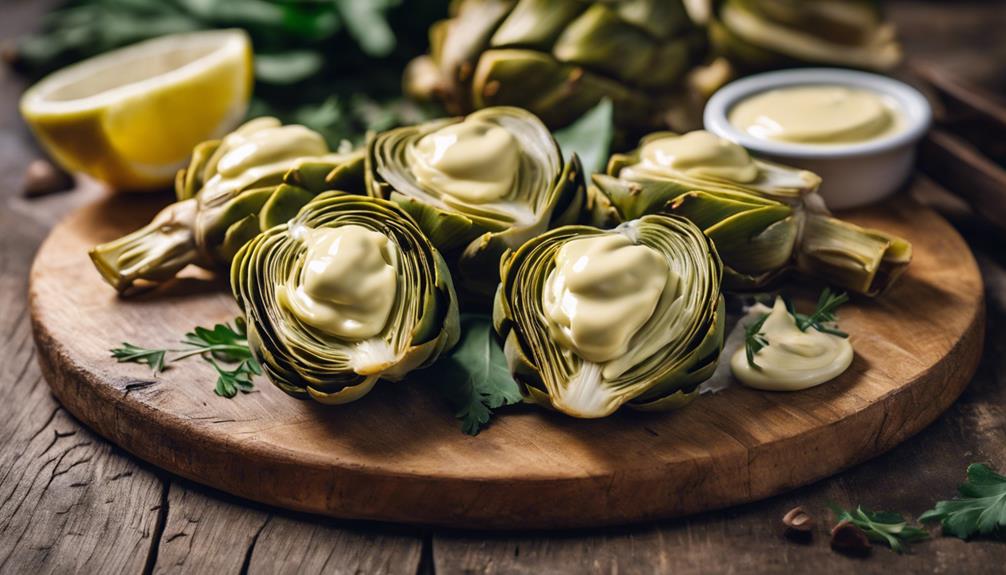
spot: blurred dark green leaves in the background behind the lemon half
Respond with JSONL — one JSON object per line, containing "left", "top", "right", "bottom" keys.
{"left": 5, "top": 0, "right": 449, "bottom": 146}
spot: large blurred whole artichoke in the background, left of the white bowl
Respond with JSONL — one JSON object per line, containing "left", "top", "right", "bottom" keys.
{"left": 404, "top": 0, "right": 706, "bottom": 128}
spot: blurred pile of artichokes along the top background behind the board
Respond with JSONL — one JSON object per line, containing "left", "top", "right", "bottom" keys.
{"left": 403, "top": 0, "right": 900, "bottom": 132}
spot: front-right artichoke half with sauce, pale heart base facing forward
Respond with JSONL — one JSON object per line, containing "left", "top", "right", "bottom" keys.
{"left": 493, "top": 215, "right": 724, "bottom": 418}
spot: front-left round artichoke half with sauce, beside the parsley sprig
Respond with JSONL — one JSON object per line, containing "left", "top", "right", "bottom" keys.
{"left": 230, "top": 192, "right": 460, "bottom": 404}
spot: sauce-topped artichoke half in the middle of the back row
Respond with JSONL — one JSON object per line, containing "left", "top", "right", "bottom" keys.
{"left": 366, "top": 108, "right": 586, "bottom": 297}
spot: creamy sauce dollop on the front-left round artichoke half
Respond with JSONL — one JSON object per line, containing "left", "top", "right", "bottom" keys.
{"left": 276, "top": 225, "right": 398, "bottom": 341}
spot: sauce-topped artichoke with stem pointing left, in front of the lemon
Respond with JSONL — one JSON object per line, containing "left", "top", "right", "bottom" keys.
{"left": 91, "top": 118, "right": 364, "bottom": 293}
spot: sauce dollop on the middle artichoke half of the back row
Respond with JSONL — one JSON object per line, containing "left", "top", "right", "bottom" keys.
{"left": 408, "top": 120, "right": 520, "bottom": 204}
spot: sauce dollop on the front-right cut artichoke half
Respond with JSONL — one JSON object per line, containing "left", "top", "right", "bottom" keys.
{"left": 542, "top": 233, "right": 677, "bottom": 364}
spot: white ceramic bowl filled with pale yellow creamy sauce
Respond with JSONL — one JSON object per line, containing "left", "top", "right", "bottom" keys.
{"left": 703, "top": 68, "right": 933, "bottom": 209}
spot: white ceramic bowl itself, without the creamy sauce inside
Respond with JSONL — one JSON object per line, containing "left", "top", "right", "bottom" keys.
{"left": 703, "top": 68, "right": 933, "bottom": 209}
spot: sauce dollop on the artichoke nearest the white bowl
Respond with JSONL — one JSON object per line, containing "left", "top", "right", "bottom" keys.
{"left": 633, "top": 130, "right": 759, "bottom": 184}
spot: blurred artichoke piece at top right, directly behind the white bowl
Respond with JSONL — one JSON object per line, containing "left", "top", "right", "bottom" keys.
{"left": 709, "top": 0, "right": 901, "bottom": 70}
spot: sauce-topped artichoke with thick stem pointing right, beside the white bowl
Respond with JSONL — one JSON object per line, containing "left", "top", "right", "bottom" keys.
{"left": 591, "top": 132, "right": 911, "bottom": 296}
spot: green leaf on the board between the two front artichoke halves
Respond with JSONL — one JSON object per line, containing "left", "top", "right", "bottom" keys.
{"left": 417, "top": 315, "right": 521, "bottom": 435}
